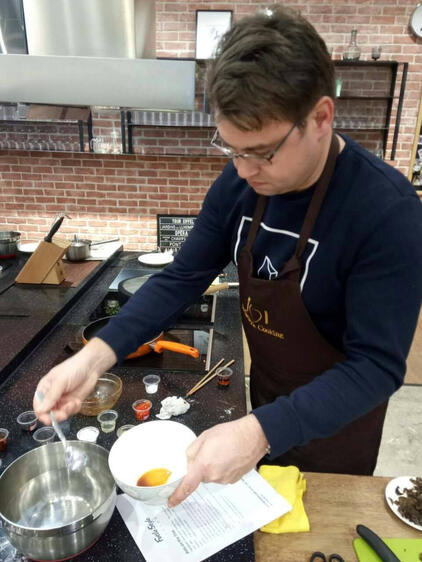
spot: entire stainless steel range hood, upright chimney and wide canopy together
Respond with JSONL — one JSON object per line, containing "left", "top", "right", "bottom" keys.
{"left": 0, "top": 0, "right": 195, "bottom": 110}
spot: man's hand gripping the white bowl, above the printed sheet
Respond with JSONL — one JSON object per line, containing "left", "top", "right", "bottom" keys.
{"left": 168, "top": 414, "right": 268, "bottom": 507}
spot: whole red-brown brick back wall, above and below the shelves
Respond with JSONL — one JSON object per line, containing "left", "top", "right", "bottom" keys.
{"left": 0, "top": 0, "right": 422, "bottom": 250}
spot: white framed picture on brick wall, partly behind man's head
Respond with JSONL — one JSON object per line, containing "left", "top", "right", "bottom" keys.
{"left": 195, "top": 10, "right": 233, "bottom": 59}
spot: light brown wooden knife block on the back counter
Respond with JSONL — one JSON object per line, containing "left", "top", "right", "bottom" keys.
{"left": 15, "top": 238, "right": 71, "bottom": 285}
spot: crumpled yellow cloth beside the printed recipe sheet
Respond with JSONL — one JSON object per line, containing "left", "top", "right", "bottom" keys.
{"left": 258, "top": 464, "right": 310, "bottom": 533}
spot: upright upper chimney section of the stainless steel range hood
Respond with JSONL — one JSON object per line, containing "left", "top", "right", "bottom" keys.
{"left": 23, "top": 0, "right": 155, "bottom": 59}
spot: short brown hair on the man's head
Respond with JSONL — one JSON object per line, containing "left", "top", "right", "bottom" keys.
{"left": 207, "top": 5, "right": 335, "bottom": 130}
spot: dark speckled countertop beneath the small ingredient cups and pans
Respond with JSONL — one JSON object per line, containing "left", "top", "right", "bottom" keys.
{"left": 0, "top": 252, "right": 255, "bottom": 562}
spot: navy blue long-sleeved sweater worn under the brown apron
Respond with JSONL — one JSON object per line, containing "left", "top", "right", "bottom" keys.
{"left": 99, "top": 137, "right": 422, "bottom": 456}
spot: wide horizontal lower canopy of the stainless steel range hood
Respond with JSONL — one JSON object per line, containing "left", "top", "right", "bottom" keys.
{"left": 0, "top": 55, "right": 195, "bottom": 111}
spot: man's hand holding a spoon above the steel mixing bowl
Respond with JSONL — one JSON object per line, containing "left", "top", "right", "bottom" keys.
{"left": 34, "top": 338, "right": 117, "bottom": 425}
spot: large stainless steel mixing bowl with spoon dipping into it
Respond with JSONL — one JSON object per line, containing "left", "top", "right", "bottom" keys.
{"left": 0, "top": 441, "right": 116, "bottom": 560}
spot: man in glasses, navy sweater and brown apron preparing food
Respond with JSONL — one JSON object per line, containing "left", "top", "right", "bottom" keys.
{"left": 34, "top": 7, "right": 422, "bottom": 505}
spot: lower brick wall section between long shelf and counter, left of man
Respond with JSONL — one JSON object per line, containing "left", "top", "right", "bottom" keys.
{"left": 0, "top": 151, "right": 223, "bottom": 250}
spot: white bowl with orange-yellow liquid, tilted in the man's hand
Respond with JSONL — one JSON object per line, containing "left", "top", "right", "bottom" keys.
{"left": 108, "top": 420, "right": 196, "bottom": 505}
